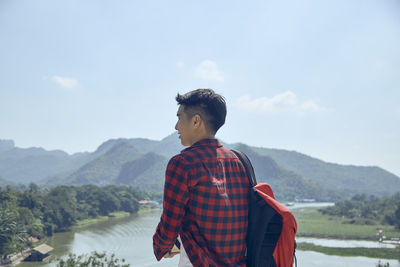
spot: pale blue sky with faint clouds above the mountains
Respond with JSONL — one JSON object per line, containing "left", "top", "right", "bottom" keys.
{"left": 0, "top": 0, "right": 400, "bottom": 176}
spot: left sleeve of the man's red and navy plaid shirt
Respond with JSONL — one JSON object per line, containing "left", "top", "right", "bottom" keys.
{"left": 153, "top": 155, "right": 189, "bottom": 261}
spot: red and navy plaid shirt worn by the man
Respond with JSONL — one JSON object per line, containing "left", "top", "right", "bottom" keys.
{"left": 153, "top": 139, "right": 249, "bottom": 266}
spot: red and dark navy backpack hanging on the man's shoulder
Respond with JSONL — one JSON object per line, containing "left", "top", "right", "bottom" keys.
{"left": 232, "top": 150, "right": 297, "bottom": 267}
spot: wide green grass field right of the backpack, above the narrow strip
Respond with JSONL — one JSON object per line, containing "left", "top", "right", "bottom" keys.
{"left": 293, "top": 208, "right": 400, "bottom": 240}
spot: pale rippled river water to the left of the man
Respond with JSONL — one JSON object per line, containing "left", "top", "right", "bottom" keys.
{"left": 18, "top": 211, "right": 179, "bottom": 267}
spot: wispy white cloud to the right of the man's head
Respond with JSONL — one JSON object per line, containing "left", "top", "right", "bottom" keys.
{"left": 236, "top": 91, "right": 326, "bottom": 115}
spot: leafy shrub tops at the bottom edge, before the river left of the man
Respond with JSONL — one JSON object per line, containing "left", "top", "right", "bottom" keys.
{"left": 57, "top": 251, "right": 130, "bottom": 267}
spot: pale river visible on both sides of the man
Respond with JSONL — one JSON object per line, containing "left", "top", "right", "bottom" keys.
{"left": 18, "top": 203, "right": 400, "bottom": 267}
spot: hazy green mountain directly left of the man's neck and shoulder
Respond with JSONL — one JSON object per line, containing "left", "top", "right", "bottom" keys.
{"left": 50, "top": 134, "right": 183, "bottom": 188}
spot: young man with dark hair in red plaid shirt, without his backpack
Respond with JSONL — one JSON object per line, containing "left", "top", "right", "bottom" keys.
{"left": 153, "top": 89, "right": 250, "bottom": 266}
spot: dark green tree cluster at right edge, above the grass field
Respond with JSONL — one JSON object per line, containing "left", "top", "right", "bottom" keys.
{"left": 320, "top": 192, "right": 400, "bottom": 230}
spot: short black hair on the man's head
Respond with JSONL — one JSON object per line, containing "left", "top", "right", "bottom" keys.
{"left": 175, "top": 89, "right": 226, "bottom": 134}
